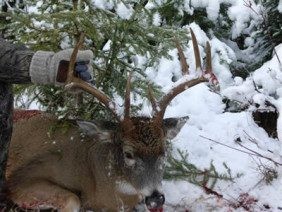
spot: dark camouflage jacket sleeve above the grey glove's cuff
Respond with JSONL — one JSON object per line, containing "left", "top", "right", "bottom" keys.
{"left": 0, "top": 37, "right": 34, "bottom": 84}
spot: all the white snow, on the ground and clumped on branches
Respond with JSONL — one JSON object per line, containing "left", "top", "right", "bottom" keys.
{"left": 7, "top": 0, "right": 282, "bottom": 211}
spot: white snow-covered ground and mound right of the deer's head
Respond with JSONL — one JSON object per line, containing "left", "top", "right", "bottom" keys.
{"left": 144, "top": 24, "right": 282, "bottom": 211}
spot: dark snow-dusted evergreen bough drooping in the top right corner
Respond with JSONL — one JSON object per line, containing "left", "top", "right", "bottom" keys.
{"left": 232, "top": 0, "right": 282, "bottom": 77}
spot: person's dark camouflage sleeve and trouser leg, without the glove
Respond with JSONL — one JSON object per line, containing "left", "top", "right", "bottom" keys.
{"left": 0, "top": 37, "right": 28, "bottom": 204}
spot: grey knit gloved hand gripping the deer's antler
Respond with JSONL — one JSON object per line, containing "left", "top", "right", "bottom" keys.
{"left": 29, "top": 49, "right": 93, "bottom": 85}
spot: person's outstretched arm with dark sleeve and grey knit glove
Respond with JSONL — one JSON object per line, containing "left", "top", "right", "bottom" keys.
{"left": 0, "top": 38, "right": 93, "bottom": 85}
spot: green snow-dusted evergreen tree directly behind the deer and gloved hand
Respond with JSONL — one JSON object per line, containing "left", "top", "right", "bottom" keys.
{"left": 0, "top": 0, "right": 187, "bottom": 118}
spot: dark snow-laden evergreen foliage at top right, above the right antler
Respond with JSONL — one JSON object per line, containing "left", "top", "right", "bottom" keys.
{"left": 149, "top": 0, "right": 282, "bottom": 78}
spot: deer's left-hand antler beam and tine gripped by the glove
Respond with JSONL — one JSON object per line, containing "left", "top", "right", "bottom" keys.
{"left": 65, "top": 33, "right": 120, "bottom": 121}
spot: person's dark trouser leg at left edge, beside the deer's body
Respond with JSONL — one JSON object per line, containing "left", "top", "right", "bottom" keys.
{"left": 0, "top": 82, "right": 13, "bottom": 203}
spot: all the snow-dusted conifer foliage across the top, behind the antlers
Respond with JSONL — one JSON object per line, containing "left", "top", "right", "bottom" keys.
{"left": 0, "top": 0, "right": 282, "bottom": 118}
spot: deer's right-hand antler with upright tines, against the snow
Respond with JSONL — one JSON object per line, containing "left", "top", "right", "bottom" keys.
{"left": 151, "top": 29, "right": 215, "bottom": 123}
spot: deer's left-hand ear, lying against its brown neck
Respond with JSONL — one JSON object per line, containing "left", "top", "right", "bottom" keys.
{"left": 77, "top": 121, "right": 115, "bottom": 142}
